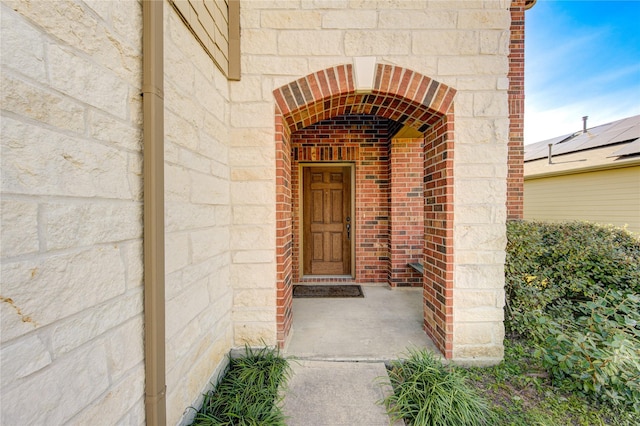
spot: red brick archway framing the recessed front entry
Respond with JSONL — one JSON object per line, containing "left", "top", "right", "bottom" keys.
{"left": 273, "top": 64, "right": 455, "bottom": 358}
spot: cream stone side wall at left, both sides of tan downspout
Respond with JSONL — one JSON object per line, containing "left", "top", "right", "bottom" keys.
{"left": 0, "top": 1, "right": 238, "bottom": 424}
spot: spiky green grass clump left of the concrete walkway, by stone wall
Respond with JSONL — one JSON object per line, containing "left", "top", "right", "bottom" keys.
{"left": 193, "top": 347, "right": 290, "bottom": 426}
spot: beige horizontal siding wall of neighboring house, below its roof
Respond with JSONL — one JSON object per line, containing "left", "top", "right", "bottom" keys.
{"left": 524, "top": 166, "right": 640, "bottom": 233}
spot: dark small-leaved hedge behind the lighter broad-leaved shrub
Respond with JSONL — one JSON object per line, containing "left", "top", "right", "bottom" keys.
{"left": 505, "top": 222, "right": 640, "bottom": 337}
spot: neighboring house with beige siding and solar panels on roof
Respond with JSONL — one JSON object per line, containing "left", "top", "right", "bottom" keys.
{"left": 524, "top": 115, "right": 640, "bottom": 233}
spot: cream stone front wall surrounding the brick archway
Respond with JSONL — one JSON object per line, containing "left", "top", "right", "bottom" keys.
{"left": 235, "top": 0, "right": 511, "bottom": 362}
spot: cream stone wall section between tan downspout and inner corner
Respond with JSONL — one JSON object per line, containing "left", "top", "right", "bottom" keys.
{"left": 164, "top": 2, "right": 235, "bottom": 424}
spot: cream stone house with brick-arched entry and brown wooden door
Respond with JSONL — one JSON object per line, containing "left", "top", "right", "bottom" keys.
{"left": 0, "top": 0, "right": 535, "bottom": 425}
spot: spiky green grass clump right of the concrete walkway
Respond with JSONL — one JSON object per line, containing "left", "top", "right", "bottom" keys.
{"left": 383, "top": 350, "right": 492, "bottom": 426}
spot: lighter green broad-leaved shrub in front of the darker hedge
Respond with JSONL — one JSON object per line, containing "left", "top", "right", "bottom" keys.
{"left": 537, "top": 290, "right": 640, "bottom": 412}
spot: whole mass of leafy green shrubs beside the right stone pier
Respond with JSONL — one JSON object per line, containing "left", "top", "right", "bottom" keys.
{"left": 505, "top": 222, "right": 640, "bottom": 410}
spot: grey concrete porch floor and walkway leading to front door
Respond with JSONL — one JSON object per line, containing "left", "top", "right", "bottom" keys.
{"left": 284, "top": 287, "right": 439, "bottom": 426}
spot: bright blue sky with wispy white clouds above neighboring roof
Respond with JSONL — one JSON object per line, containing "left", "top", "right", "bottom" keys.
{"left": 525, "top": 0, "right": 640, "bottom": 144}
